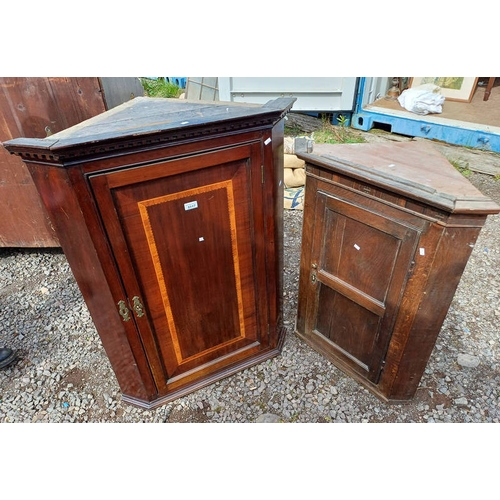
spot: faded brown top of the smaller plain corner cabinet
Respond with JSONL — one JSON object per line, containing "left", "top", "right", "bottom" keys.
{"left": 297, "top": 141, "right": 500, "bottom": 213}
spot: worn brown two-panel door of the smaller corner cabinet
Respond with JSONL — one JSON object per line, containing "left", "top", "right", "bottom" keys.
{"left": 306, "top": 192, "right": 419, "bottom": 383}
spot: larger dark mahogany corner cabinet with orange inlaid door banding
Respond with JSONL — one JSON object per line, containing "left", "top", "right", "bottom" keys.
{"left": 4, "top": 97, "right": 295, "bottom": 408}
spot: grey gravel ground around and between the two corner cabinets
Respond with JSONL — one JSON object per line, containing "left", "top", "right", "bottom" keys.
{"left": 0, "top": 135, "right": 500, "bottom": 423}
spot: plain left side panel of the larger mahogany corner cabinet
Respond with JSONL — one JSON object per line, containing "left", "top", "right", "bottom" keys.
{"left": 28, "top": 164, "right": 153, "bottom": 400}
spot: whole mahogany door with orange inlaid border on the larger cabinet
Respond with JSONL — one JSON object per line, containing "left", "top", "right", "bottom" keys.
{"left": 90, "top": 143, "right": 268, "bottom": 390}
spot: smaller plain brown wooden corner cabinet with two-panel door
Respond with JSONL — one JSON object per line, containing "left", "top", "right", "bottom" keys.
{"left": 296, "top": 141, "right": 500, "bottom": 403}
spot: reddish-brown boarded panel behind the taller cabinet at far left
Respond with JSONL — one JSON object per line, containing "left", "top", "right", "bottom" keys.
{"left": 0, "top": 77, "right": 105, "bottom": 247}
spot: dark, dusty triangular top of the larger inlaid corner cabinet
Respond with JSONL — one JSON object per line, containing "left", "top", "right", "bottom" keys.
{"left": 4, "top": 97, "right": 295, "bottom": 152}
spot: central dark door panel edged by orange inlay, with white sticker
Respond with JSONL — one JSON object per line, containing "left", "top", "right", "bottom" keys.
{"left": 138, "top": 180, "right": 245, "bottom": 363}
